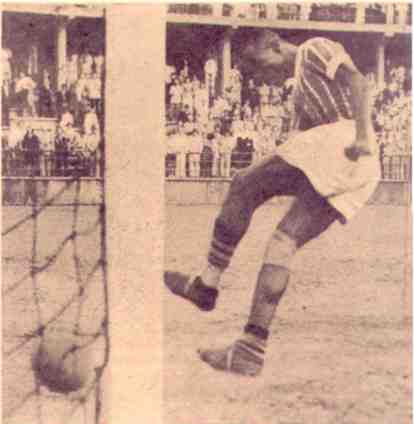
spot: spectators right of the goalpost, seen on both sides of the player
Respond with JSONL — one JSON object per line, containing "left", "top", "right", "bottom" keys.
{"left": 166, "top": 59, "right": 411, "bottom": 178}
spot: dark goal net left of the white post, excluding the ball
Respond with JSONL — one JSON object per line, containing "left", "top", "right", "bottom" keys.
{"left": 2, "top": 177, "right": 109, "bottom": 424}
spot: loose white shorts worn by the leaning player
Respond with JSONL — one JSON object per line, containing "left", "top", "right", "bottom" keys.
{"left": 277, "top": 120, "right": 381, "bottom": 220}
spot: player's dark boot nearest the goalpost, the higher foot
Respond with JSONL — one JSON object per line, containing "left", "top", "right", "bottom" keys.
{"left": 164, "top": 271, "right": 218, "bottom": 311}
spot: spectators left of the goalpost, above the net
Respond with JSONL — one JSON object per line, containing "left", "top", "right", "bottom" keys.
{"left": 2, "top": 48, "right": 104, "bottom": 176}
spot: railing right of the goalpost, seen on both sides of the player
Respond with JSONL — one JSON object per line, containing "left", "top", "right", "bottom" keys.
{"left": 165, "top": 152, "right": 412, "bottom": 182}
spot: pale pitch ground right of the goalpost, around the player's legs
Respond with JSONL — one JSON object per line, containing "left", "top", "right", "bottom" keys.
{"left": 164, "top": 206, "right": 411, "bottom": 424}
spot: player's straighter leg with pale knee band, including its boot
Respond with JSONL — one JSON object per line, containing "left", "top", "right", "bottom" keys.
{"left": 200, "top": 181, "right": 341, "bottom": 375}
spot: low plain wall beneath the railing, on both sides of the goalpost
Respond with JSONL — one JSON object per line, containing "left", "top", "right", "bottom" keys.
{"left": 2, "top": 177, "right": 411, "bottom": 206}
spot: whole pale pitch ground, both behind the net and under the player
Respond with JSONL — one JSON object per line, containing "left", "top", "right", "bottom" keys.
{"left": 2, "top": 205, "right": 411, "bottom": 424}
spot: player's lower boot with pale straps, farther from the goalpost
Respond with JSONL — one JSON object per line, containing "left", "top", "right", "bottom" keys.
{"left": 198, "top": 340, "right": 264, "bottom": 377}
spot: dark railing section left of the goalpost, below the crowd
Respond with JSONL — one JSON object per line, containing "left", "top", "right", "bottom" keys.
{"left": 2, "top": 149, "right": 101, "bottom": 178}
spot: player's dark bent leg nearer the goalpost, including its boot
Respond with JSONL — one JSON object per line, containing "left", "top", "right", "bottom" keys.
{"left": 164, "top": 155, "right": 306, "bottom": 310}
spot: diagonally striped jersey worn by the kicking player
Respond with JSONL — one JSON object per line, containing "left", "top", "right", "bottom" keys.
{"left": 294, "top": 37, "right": 355, "bottom": 130}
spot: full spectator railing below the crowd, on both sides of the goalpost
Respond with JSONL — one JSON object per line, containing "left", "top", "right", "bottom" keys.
{"left": 2, "top": 149, "right": 412, "bottom": 181}
